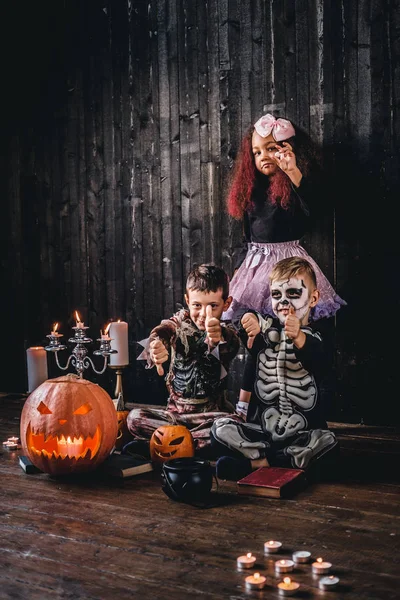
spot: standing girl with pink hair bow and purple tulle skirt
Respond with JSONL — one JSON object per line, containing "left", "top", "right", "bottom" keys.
{"left": 223, "top": 114, "right": 346, "bottom": 321}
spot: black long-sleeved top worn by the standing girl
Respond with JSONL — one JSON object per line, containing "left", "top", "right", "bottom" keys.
{"left": 235, "top": 175, "right": 324, "bottom": 269}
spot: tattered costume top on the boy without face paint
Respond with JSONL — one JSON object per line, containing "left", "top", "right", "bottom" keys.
{"left": 142, "top": 309, "right": 240, "bottom": 413}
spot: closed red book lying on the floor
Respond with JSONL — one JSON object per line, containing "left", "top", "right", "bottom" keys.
{"left": 237, "top": 467, "right": 306, "bottom": 498}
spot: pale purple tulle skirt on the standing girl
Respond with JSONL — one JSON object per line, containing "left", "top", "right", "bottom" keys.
{"left": 222, "top": 240, "right": 346, "bottom": 321}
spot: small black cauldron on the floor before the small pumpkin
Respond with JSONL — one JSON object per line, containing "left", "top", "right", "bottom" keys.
{"left": 161, "top": 457, "right": 214, "bottom": 505}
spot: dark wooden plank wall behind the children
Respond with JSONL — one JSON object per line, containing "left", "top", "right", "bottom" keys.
{"left": 0, "top": 0, "right": 400, "bottom": 424}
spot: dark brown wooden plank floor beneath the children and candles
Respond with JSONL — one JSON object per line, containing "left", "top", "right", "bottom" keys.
{"left": 0, "top": 396, "right": 400, "bottom": 600}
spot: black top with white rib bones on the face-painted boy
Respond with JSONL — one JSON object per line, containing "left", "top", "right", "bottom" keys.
{"left": 240, "top": 313, "right": 328, "bottom": 434}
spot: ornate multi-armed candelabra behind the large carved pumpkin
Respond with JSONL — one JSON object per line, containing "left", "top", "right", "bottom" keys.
{"left": 45, "top": 323, "right": 118, "bottom": 379}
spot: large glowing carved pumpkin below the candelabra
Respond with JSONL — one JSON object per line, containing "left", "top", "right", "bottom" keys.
{"left": 20, "top": 373, "right": 118, "bottom": 475}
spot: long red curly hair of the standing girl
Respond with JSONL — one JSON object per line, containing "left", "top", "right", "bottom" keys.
{"left": 226, "top": 126, "right": 317, "bottom": 220}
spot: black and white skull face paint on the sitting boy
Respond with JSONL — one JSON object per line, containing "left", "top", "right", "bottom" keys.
{"left": 271, "top": 277, "right": 310, "bottom": 324}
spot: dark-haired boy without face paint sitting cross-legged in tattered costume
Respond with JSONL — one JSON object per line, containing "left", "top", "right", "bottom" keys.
{"left": 127, "top": 265, "right": 240, "bottom": 453}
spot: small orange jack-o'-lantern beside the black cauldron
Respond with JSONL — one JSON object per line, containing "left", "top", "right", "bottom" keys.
{"left": 150, "top": 425, "right": 194, "bottom": 463}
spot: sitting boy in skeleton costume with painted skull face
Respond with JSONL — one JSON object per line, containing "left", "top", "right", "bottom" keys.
{"left": 211, "top": 257, "right": 338, "bottom": 481}
